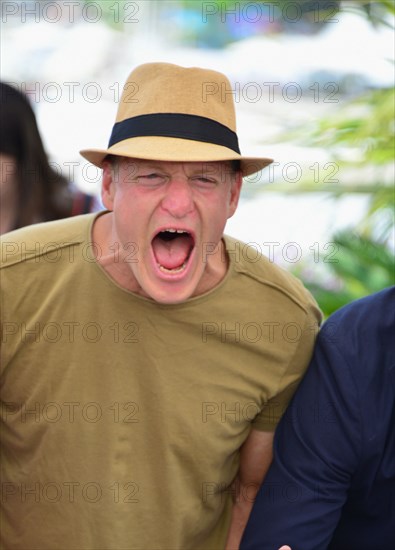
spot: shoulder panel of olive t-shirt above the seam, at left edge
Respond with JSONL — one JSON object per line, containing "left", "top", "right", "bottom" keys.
{"left": 0, "top": 214, "right": 95, "bottom": 269}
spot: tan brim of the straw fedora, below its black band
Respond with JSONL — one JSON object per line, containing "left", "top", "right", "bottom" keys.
{"left": 80, "top": 136, "right": 273, "bottom": 177}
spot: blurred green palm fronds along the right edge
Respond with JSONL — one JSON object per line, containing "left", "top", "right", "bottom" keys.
{"left": 280, "top": 0, "right": 395, "bottom": 316}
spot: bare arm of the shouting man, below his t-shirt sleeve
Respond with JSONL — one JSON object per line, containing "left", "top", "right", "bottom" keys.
{"left": 226, "top": 429, "right": 273, "bottom": 550}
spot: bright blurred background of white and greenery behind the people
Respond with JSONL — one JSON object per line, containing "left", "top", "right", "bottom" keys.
{"left": 0, "top": 0, "right": 395, "bottom": 315}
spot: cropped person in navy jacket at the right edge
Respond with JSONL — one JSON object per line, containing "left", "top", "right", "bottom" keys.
{"left": 241, "top": 287, "right": 395, "bottom": 550}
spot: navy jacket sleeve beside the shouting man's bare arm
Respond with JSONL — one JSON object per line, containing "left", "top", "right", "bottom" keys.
{"left": 240, "top": 322, "right": 362, "bottom": 550}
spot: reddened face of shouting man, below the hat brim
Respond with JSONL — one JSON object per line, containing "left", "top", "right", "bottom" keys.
{"left": 102, "top": 159, "right": 241, "bottom": 303}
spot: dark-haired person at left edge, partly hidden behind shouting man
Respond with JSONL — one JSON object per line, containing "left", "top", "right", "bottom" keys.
{"left": 0, "top": 82, "right": 98, "bottom": 233}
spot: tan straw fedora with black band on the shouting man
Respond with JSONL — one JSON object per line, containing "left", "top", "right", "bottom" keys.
{"left": 80, "top": 63, "right": 273, "bottom": 176}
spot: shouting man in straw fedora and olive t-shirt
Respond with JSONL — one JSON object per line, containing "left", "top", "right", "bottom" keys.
{"left": 2, "top": 63, "right": 320, "bottom": 550}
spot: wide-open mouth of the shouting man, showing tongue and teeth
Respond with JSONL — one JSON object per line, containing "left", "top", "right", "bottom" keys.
{"left": 151, "top": 228, "right": 195, "bottom": 274}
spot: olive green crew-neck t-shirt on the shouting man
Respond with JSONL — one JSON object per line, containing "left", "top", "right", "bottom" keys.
{"left": 1, "top": 215, "right": 320, "bottom": 550}
